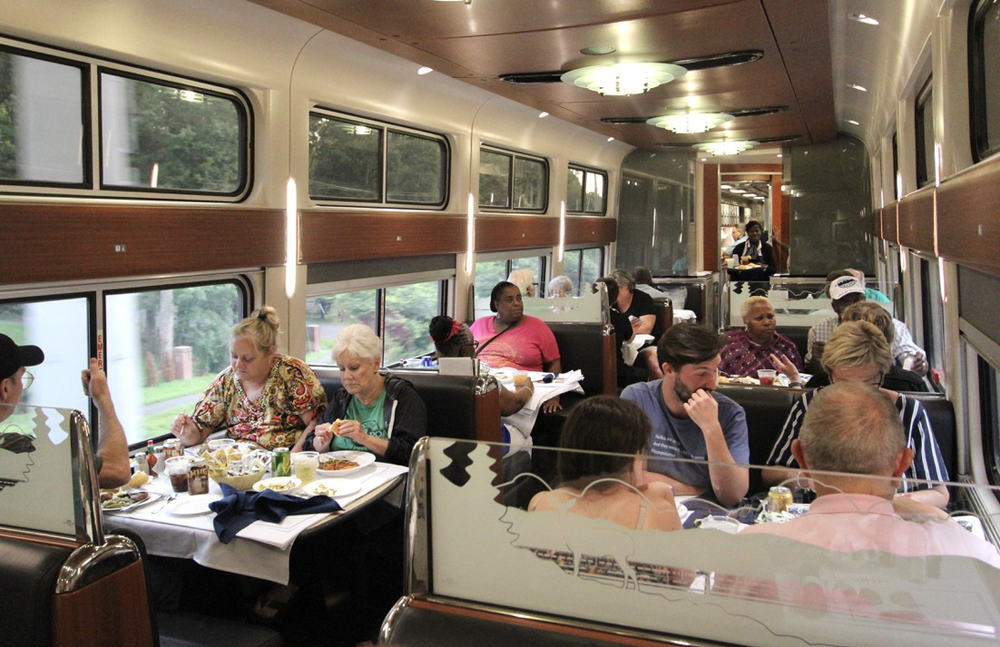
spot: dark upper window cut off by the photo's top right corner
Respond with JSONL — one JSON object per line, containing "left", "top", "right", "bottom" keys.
{"left": 969, "top": 0, "right": 1000, "bottom": 162}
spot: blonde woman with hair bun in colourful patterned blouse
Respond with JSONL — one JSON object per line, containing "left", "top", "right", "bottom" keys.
{"left": 170, "top": 306, "right": 326, "bottom": 449}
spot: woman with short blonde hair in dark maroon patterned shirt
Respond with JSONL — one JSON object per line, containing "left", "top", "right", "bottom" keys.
{"left": 719, "top": 297, "right": 802, "bottom": 386}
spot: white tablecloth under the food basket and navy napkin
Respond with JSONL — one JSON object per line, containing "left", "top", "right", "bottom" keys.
{"left": 104, "top": 463, "right": 407, "bottom": 584}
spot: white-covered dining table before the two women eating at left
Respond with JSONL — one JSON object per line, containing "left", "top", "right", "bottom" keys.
{"left": 103, "top": 450, "right": 408, "bottom": 584}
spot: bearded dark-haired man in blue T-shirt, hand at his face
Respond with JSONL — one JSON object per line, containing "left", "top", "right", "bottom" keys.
{"left": 622, "top": 324, "right": 750, "bottom": 507}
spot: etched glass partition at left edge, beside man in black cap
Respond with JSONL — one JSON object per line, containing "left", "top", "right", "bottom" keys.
{"left": 0, "top": 404, "right": 94, "bottom": 539}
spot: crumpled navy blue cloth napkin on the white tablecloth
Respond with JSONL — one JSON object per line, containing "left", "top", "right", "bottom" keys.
{"left": 208, "top": 483, "right": 342, "bottom": 544}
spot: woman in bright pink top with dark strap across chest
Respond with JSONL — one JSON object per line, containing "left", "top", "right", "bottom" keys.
{"left": 471, "top": 281, "right": 562, "bottom": 411}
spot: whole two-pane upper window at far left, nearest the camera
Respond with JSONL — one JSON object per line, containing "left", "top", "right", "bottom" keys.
{"left": 0, "top": 38, "right": 251, "bottom": 201}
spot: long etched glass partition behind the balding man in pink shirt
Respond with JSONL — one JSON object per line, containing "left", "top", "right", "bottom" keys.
{"left": 409, "top": 438, "right": 1000, "bottom": 646}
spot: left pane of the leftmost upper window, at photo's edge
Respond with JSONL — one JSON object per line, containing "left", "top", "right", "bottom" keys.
{"left": 0, "top": 45, "right": 90, "bottom": 187}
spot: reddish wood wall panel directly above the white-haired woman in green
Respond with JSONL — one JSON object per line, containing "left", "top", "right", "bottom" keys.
{"left": 299, "top": 210, "right": 466, "bottom": 263}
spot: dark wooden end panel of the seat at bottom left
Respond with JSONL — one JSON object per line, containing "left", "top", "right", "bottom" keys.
{"left": 52, "top": 561, "right": 153, "bottom": 647}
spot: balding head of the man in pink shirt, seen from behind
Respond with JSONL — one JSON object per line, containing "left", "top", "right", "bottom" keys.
{"left": 799, "top": 382, "right": 906, "bottom": 476}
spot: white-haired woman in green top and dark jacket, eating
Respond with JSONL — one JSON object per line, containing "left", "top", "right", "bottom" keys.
{"left": 293, "top": 324, "right": 427, "bottom": 465}
